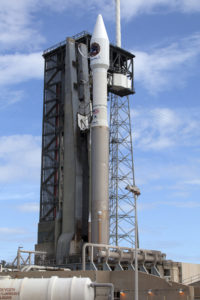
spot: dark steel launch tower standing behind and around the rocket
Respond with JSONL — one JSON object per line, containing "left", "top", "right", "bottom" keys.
{"left": 36, "top": 25, "right": 134, "bottom": 265}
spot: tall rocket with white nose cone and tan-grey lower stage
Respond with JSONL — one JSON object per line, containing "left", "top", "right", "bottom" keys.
{"left": 90, "top": 15, "right": 109, "bottom": 244}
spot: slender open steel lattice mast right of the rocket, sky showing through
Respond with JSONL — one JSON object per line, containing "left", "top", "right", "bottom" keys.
{"left": 109, "top": 94, "right": 135, "bottom": 247}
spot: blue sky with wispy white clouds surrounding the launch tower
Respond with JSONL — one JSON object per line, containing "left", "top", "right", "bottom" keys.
{"left": 0, "top": 0, "right": 200, "bottom": 263}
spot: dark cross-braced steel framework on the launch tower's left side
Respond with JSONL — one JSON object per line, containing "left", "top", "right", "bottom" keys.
{"left": 40, "top": 47, "right": 65, "bottom": 222}
